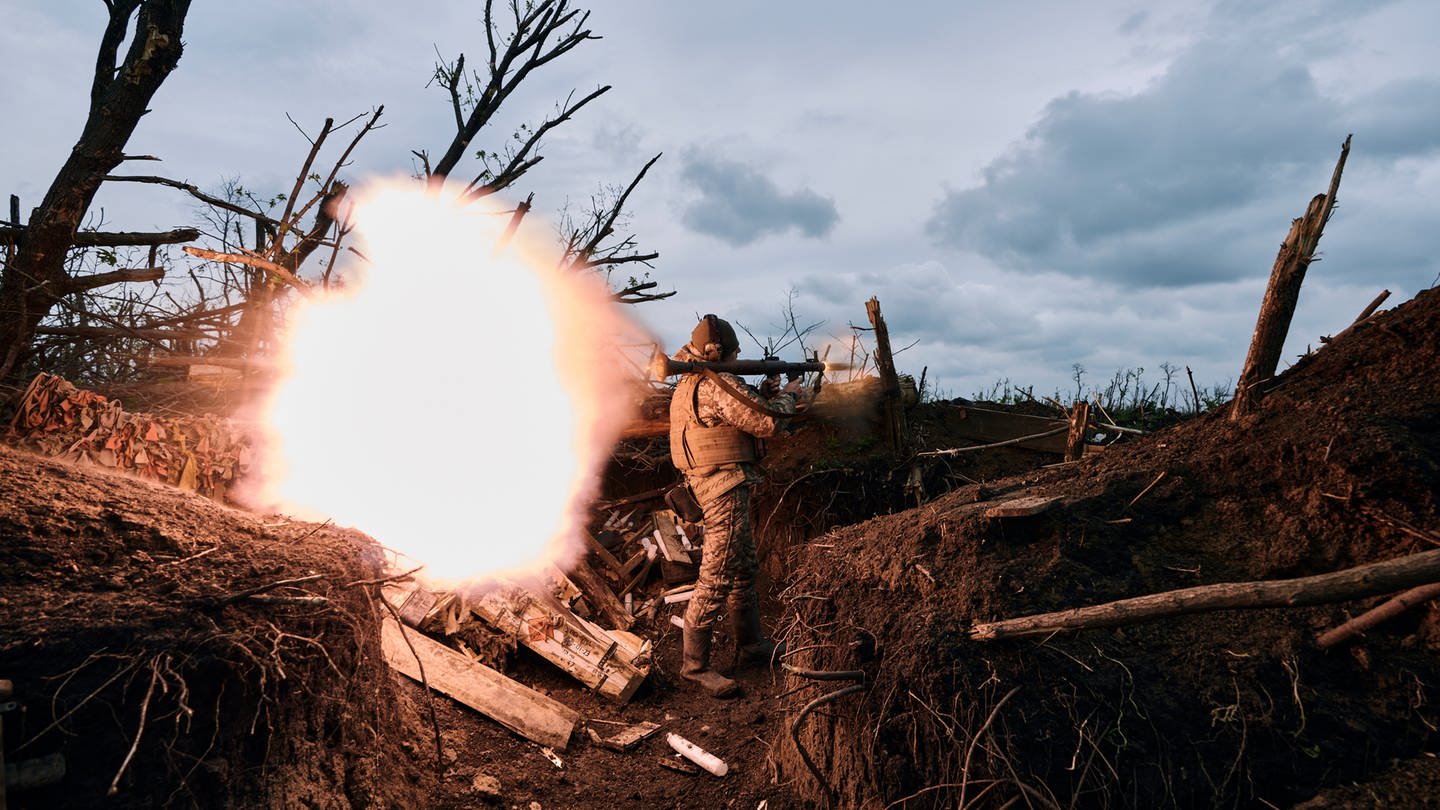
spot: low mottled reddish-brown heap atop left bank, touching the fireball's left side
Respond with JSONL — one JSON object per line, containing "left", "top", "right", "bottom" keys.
{"left": 9, "top": 372, "right": 252, "bottom": 502}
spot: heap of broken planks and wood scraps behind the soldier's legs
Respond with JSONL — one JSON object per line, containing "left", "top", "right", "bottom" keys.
{"left": 380, "top": 509, "right": 701, "bottom": 751}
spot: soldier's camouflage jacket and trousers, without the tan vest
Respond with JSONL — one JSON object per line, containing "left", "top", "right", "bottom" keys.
{"left": 670, "top": 373, "right": 795, "bottom": 630}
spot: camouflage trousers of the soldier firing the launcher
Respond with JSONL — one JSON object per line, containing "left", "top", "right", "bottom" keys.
{"left": 685, "top": 484, "right": 759, "bottom": 630}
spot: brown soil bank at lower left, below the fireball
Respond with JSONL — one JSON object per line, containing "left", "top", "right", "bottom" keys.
{"left": 0, "top": 447, "right": 429, "bottom": 809}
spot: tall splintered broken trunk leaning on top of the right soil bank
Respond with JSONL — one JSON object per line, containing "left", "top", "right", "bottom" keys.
{"left": 1230, "top": 135, "right": 1351, "bottom": 421}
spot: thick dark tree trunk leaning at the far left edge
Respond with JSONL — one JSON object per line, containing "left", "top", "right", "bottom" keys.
{"left": 0, "top": 0, "right": 197, "bottom": 379}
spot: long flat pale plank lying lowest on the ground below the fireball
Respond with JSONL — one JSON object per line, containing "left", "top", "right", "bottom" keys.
{"left": 380, "top": 618, "right": 580, "bottom": 751}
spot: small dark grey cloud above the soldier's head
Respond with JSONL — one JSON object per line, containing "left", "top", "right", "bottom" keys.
{"left": 681, "top": 154, "right": 840, "bottom": 245}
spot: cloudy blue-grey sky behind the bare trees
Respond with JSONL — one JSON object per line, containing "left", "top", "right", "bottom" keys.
{"left": 0, "top": 0, "right": 1440, "bottom": 399}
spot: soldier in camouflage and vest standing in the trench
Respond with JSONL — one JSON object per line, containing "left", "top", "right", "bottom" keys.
{"left": 670, "top": 309, "right": 795, "bottom": 698}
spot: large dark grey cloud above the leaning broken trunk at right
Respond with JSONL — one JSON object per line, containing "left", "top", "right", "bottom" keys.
{"left": 926, "top": 7, "right": 1440, "bottom": 287}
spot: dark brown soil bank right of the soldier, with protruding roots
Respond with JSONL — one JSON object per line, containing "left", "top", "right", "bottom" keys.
{"left": 779, "top": 291, "right": 1440, "bottom": 807}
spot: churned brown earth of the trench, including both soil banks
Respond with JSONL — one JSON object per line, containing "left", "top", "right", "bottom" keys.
{"left": 0, "top": 291, "right": 1440, "bottom": 809}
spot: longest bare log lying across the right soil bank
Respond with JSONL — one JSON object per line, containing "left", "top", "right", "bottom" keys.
{"left": 971, "top": 549, "right": 1440, "bottom": 641}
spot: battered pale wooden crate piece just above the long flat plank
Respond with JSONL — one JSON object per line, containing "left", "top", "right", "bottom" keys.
{"left": 469, "top": 584, "right": 649, "bottom": 703}
